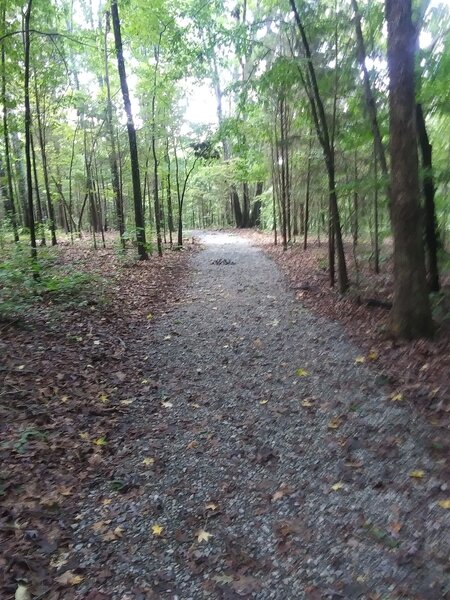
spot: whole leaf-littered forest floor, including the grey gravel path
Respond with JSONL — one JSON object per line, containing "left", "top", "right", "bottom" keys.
{"left": 0, "top": 232, "right": 450, "bottom": 600}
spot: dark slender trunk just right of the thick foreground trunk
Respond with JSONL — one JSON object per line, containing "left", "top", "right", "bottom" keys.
{"left": 416, "top": 104, "right": 440, "bottom": 292}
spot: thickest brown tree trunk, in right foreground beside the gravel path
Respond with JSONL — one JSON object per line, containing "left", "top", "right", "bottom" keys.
{"left": 386, "top": 0, "right": 433, "bottom": 339}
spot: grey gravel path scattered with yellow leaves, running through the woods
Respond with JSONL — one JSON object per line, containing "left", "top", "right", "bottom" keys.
{"left": 69, "top": 233, "right": 450, "bottom": 600}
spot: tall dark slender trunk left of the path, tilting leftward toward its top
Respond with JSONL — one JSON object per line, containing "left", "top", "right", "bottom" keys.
{"left": 111, "top": 0, "right": 148, "bottom": 260}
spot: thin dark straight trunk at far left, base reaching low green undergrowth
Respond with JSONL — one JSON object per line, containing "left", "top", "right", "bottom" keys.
{"left": 24, "top": 0, "right": 37, "bottom": 262}
